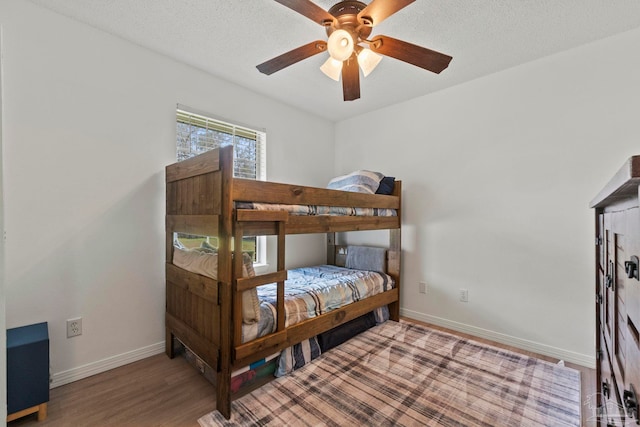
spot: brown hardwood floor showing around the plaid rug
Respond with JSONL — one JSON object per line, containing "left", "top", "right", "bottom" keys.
{"left": 7, "top": 319, "right": 596, "bottom": 427}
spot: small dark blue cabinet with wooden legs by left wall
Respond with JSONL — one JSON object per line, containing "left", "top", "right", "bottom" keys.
{"left": 7, "top": 322, "right": 49, "bottom": 421}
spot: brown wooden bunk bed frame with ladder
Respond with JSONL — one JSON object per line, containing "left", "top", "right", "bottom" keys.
{"left": 165, "top": 146, "right": 401, "bottom": 418}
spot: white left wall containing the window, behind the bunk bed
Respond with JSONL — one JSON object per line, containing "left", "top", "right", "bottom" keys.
{"left": 0, "top": 0, "right": 333, "bottom": 385}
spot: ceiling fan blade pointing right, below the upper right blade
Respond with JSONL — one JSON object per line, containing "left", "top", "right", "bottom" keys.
{"left": 369, "top": 36, "right": 453, "bottom": 74}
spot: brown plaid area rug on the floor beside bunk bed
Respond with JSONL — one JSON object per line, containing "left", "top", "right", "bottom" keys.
{"left": 198, "top": 321, "right": 580, "bottom": 427}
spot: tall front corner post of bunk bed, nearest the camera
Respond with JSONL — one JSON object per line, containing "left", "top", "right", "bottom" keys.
{"left": 216, "top": 146, "right": 233, "bottom": 419}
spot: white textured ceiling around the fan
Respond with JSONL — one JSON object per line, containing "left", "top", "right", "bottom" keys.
{"left": 30, "top": 0, "right": 640, "bottom": 120}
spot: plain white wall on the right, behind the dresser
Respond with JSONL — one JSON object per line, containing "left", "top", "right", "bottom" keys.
{"left": 335, "top": 30, "right": 640, "bottom": 365}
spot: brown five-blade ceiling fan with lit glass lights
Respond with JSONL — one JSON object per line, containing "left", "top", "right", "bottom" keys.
{"left": 256, "top": 0, "right": 453, "bottom": 101}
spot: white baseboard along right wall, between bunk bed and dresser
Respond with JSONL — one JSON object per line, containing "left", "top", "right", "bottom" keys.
{"left": 400, "top": 308, "right": 596, "bottom": 369}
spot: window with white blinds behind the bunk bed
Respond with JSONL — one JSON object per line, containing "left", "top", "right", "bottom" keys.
{"left": 176, "top": 106, "right": 267, "bottom": 264}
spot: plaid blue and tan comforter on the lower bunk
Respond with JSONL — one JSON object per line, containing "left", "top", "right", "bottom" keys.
{"left": 242, "top": 265, "right": 395, "bottom": 342}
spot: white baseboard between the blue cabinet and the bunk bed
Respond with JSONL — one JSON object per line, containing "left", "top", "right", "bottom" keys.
{"left": 51, "top": 341, "right": 164, "bottom": 388}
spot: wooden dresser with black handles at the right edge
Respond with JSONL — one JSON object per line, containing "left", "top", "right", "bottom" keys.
{"left": 588, "top": 156, "right": 640, "bottom": 426}
